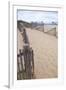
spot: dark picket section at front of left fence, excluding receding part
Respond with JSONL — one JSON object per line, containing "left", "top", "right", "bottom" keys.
{"left": 17, "top": 47, "right": 34, "bottom": 80}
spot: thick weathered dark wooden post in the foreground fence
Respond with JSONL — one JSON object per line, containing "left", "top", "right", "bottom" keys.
{"left": 23, "top": 45, "right": 31, "bottom": 79}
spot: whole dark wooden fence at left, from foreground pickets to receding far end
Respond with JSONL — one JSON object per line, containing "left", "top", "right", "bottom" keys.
{"left": 17, "top": 21, "right": 34, "bottom": 80}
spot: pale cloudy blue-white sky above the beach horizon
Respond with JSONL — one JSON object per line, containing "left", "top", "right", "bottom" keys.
{"left": 17, "top": 10, "right": 58, "bottom": 23}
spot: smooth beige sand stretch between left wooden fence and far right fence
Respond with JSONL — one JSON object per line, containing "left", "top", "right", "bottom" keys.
{"left": 26, "top": 29, "right": 58, "bottom": 79}
